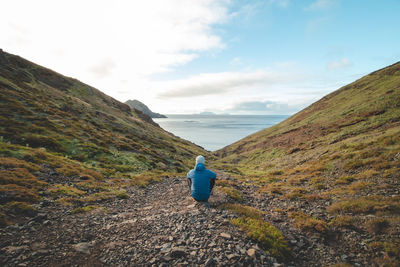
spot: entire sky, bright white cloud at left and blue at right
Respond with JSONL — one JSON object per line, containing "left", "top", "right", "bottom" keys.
{"left": 0, "top": 0, "right": 400, "bottom": 115}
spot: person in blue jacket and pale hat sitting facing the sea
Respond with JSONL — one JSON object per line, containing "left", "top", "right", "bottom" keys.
{"left": 187, "top": 156, "right": 217, "bottom": 202}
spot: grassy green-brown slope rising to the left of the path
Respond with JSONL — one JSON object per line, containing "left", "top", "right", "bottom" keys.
{"left": 0, "top": 50, "right": 206, "bottom": 225}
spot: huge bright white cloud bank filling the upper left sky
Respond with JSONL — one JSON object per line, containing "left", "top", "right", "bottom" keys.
{"left": 0, "top": 0, "right": 230, "bottom": 98}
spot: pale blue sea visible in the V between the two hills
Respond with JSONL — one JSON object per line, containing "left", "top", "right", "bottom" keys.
{"left": 153, "top": 114, "right": 289, "bottom": 151}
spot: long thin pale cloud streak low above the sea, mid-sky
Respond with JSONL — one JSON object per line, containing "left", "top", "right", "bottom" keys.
{"left": 158, "top": 70, "right": 295, "bottom": 98}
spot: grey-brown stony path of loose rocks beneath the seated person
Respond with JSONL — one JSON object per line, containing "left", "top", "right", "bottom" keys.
{"left": 0, "top": 177, "right": 281, "bottom": 266}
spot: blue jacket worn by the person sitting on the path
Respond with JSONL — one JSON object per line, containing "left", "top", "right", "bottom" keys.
{"left": 187, "top": 163, "right": 217, "bottom": 201}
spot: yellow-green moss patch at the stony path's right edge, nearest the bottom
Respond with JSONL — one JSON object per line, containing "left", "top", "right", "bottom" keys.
{"left": 231, "top": 217, "right": 290, "bottom": 261}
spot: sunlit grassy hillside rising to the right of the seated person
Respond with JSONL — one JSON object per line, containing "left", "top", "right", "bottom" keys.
{"left": 214, "top": 63, "right": 400, "bottom": 266}
